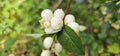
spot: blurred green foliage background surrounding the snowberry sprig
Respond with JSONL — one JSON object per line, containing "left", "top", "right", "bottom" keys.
{"left": 0, "top": 0, "right": 120, "bottom": 56}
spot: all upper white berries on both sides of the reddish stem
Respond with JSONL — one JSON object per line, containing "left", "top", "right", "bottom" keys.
{"left": 40, "top": 9, "right": 86, "bottom": 34}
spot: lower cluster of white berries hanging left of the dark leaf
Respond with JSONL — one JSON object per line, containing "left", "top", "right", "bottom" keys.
{"left": 41, "top": 37, "right": 62, "bottom": 56}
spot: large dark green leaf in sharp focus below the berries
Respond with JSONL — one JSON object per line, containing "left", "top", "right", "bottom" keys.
{"left": 57, "top": 26, "right": 84, "bottom": 55}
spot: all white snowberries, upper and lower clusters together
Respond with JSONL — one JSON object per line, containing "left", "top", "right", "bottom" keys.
{"left": 40, "top": 9, "right": 86, "bottom": 56}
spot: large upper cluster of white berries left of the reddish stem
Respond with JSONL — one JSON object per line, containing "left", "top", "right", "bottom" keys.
{"left": 40, "top": 9, "right": 64, "bottom": 34}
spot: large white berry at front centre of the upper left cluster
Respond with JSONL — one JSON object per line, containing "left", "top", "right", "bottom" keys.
{"left": 51, "top": 17, "right": 63, "bottom": 29}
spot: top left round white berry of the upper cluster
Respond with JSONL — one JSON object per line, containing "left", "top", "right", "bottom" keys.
{"left": 41, "top": 9, "right": 53, "bottom": 21}
